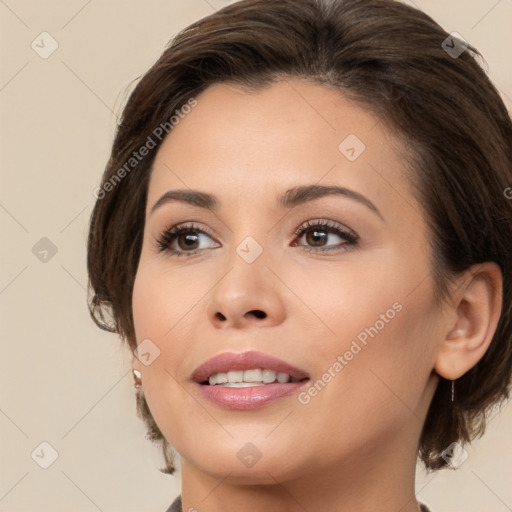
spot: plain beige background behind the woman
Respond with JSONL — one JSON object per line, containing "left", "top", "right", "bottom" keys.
{"left": 0, "top": 0, "right": 512, "bottom": 512}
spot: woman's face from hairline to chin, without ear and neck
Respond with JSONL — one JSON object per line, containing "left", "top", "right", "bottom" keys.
{"left": 133, "top": 80, "right": 442, "bottom": 483}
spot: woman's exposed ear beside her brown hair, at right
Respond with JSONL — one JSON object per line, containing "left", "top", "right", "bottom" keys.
{"left": 434, "top": 262, "right": 503, "bottom": 380}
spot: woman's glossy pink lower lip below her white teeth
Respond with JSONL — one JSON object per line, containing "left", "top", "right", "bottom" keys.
{"left": 197, "top": 380, "right": 308, "bottom": 410}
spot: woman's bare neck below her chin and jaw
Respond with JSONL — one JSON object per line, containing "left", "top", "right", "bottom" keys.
{"left": 181, "top": 431, "right": 420, "bottom": 512}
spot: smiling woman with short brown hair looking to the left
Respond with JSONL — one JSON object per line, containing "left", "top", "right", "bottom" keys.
{"left": 88, "top": 0, "right": 512, "bottom": 512}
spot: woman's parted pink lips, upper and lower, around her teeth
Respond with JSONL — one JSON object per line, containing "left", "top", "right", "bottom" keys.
{"left": 191, "top": 351, "right": 309, "bottom": 410}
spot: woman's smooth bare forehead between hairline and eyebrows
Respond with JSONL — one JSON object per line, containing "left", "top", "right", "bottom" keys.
{"left": 148, "top": 80, "right": 413, "bottom": 222}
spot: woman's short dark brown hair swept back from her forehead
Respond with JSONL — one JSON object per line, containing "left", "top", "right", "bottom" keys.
{"left": 87, "top": 0, "right": 512, "bottom": 473}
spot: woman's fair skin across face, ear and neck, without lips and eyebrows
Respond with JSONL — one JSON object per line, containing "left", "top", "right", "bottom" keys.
{"left": 132, "top": 80, "right": 501, "bottom": 512}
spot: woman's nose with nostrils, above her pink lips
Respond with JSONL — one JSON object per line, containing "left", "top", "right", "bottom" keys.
{"left": 207, "top": 253, "right": 285, "bottom": 329}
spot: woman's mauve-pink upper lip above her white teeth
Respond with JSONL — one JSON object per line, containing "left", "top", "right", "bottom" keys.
{"left": 191, "top": 351, "right": 309, "bottom": 383}
